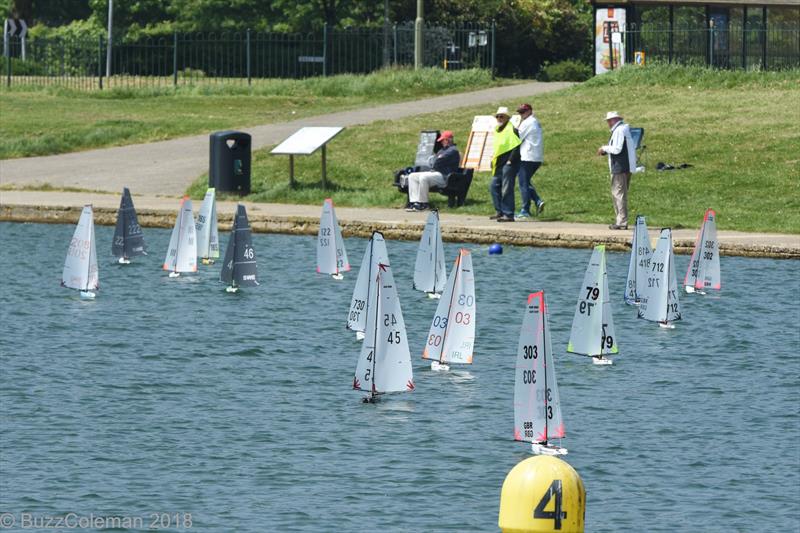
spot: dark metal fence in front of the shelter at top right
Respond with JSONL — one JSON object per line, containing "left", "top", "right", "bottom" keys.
{"left": 624, "top": 24, "right": 800, "bottom": 70}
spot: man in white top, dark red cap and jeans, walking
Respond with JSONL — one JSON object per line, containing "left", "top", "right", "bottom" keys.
{"left": 515, "top": 104, "right": 544, "bottom": 220}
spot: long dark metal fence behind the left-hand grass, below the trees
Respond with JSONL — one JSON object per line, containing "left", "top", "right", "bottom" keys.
{"left": 4, "top": 23, "right": 494, "bottom": 89}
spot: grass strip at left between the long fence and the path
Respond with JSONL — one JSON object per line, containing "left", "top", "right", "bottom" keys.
{"left": 0, "top": 69, "right": 507, "bottom": 159}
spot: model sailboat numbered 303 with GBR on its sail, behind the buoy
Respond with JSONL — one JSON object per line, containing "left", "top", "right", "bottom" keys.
{"left": 514, "top": 291, "right": 567, "bottom": 455}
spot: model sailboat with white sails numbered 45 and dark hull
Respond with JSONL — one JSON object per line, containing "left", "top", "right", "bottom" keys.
{"left": 353, "top": 264, "right": 414, "bottom": 403}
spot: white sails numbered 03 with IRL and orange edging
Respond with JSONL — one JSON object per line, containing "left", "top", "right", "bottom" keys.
{"left": 422, "top": 249, "right": 475, "bottom": 364}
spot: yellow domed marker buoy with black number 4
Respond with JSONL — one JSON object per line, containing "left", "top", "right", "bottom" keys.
{"left": 497, "top": 455, "right": 586, "bottom": 533}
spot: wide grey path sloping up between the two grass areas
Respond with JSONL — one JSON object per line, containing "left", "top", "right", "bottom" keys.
{"left": 0, "top": 82, "right": 572, "bottom": 195}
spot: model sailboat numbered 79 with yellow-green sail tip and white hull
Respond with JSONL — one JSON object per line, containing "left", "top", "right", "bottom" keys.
{"left": 567, "top": 244, "right": 619, "bottom": 365}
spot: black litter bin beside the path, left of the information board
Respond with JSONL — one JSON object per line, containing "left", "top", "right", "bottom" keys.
{"left": 208, "top": 131, "right": 251, "bottom": 194}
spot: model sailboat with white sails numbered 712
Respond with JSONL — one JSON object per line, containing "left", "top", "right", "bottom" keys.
{"left": 638, "top": 228, "right": 681, "bottom": 329}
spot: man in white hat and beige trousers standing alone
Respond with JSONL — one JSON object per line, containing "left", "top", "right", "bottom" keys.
{"left": 597, "top": 111, "right": 636, "bottom": 230}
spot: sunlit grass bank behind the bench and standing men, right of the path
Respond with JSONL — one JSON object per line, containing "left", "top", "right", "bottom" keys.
{"left": 191, "top": 66, "right": 800, "bottom": 233}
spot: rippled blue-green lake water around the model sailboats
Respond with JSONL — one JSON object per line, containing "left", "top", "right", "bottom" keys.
{"left": 0, "top": 223, "right": 800, "bottom": 532}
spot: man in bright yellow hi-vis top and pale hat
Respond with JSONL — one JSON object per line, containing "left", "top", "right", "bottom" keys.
{"left": 489, "top": 107, "right": 520, "bottom": 222}
